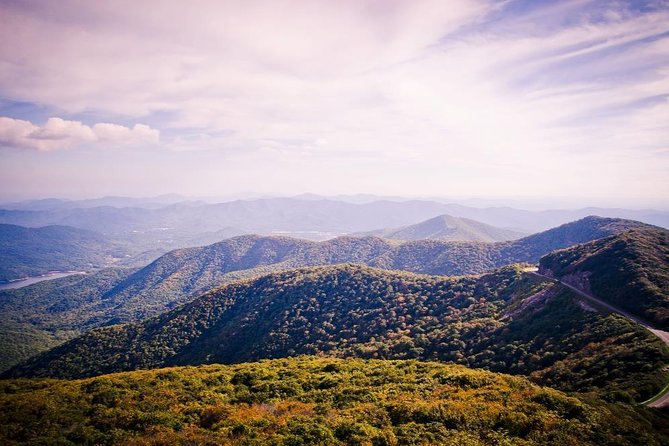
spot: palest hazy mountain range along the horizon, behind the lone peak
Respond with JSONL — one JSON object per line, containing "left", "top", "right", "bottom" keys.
{"left": 0, "top": 197, "right": 669, "bottom": 239}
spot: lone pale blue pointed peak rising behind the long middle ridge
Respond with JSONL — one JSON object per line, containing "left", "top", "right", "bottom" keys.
{"left": 351, "top": 215, "right": 525, "bottom": 242}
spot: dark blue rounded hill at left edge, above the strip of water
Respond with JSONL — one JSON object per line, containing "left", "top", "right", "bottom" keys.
{"left": 0, "top": 224, "right": 120, "bottom": 282}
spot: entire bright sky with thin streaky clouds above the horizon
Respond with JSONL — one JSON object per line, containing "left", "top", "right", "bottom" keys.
{"left": 0, "top": 0, "right": 669, "bottom": 208}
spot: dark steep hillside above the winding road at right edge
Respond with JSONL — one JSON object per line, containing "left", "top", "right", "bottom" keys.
{"left": 540, "top": 228, "right": 669, "bottom": 329}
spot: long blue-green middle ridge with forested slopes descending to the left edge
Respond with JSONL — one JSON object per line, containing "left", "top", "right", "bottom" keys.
{"left": 0, "top": 217, "right": 648, "bottom": 367}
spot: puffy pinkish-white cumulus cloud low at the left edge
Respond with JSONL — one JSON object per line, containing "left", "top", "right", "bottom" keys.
{"left": 0, "top": 117, "right": 159, "bottom": 151}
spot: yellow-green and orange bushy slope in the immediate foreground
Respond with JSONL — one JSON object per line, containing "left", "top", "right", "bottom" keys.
{"left": 0, "top": 357, "right": 669, "bottom": 446}
